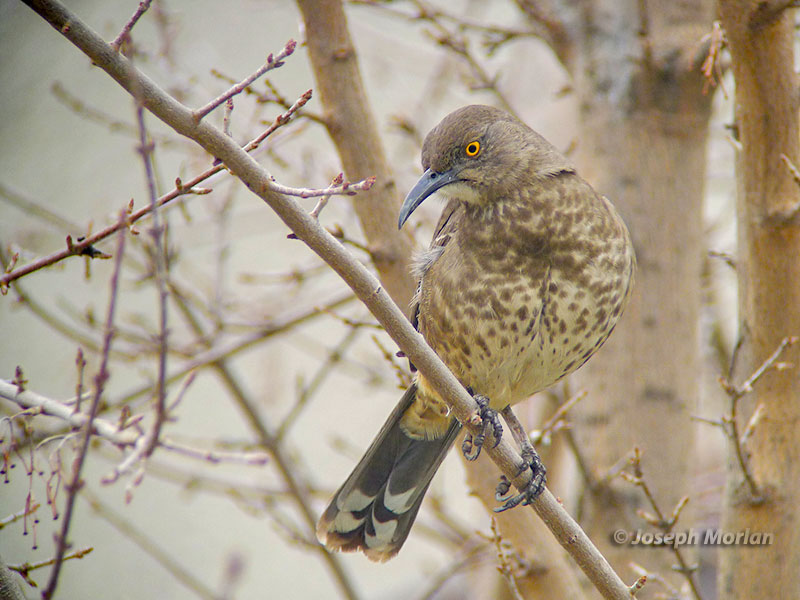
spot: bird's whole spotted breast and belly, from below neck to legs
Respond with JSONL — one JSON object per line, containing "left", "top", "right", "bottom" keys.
{"left": 419, "top": 192, "right": 633, "bottom": 408}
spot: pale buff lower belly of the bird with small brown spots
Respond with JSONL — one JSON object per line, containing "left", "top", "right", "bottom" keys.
{"left": 420, "top": 282, "right": 613, "bottom": 409}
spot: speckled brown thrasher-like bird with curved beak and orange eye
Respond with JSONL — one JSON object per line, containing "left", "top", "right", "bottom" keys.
{"left": 316, "top": 105, "right": 636, "bottom": 562}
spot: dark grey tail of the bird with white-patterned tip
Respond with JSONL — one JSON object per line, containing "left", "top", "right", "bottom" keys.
{"left": 317, "top": 384, "right": 461, "bottom": 562}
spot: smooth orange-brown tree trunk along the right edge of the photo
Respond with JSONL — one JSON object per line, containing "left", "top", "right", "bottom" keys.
{"left": 718, "top": 0, "right": 800, "bottom": 599}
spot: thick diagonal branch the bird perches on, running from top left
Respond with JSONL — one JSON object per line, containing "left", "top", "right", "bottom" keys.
{"left": 24, "top": 0, "right": 631, "bottom": 599}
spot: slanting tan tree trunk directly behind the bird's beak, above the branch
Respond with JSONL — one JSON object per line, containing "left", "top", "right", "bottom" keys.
{"left": 297, "top": 0, "right": 416, "bottom": 308}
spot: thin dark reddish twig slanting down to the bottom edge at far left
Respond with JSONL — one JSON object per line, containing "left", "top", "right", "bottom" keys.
{"left": 42, "top": 212, "right": 126, "bottom": 599}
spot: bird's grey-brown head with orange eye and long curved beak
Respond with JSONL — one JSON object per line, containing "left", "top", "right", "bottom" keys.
{"left": 398, "top": 105, "right": 572, "bottom": 227}
